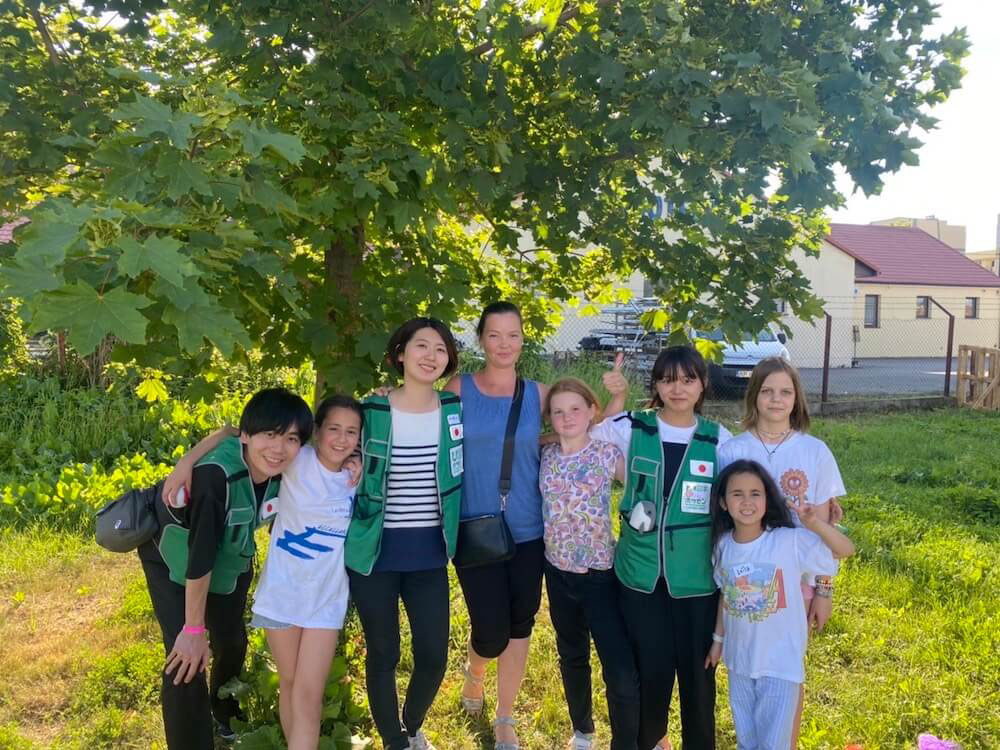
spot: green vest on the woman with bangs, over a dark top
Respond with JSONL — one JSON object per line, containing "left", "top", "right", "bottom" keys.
{"left": 615, "top": 410, "right": 719, "bottom": 598}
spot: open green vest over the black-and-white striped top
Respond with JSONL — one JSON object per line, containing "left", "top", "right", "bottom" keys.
{"left": 344, "top": 392, "right": 463, "bottom": 575}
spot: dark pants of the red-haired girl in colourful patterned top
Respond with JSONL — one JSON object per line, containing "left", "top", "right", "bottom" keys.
{"left": 545, "top": 562, "right": 639, "bottom": 750}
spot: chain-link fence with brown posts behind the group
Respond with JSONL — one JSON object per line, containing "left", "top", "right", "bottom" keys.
{"left": 492, "top": 295, "right": 1000, "bottom": 401}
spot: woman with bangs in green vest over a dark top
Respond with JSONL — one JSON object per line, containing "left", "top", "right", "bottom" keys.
{"left": 590, "top": 346, "right": 731, "bottom": 750}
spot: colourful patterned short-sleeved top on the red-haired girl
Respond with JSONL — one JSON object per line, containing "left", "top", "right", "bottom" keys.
{"left": 538, "top": 440, "right": 621, "bottom": 573}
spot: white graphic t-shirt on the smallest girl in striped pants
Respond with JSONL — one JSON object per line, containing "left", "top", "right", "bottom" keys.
{"left": 714, "top": 528, "right": 835, "bottom": 682}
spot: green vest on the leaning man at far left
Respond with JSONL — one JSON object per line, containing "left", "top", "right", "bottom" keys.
{"left": 159, "top": 437, "right": 281, "bottom": 594}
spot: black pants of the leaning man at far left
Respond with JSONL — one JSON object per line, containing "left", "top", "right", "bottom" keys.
{"left": 140, "top": 542, "right": 253, "bottom": 750}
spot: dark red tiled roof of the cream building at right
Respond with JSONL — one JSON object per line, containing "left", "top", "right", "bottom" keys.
{"left": 826, "top": 224, "right": 1000, "bottom": 287}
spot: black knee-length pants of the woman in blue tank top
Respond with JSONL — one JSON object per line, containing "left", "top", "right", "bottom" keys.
{"left": 455, "top": 539, "right": 545, "bottom": 659}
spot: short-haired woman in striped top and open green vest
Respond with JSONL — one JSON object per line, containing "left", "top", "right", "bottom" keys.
{"left": 344, "top": 318, "right": 463, "bottom": 750}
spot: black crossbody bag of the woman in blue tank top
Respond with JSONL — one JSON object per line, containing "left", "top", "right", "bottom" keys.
{"left": 453, "top": 378, "right": 524, "bottom": 568}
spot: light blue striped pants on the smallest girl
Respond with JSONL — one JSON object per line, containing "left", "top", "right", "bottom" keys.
{"left": 729, "top": 672, "right": 800, "bottom": 750}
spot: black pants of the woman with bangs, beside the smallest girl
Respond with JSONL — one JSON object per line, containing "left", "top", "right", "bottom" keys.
{"left": 619, "top": 578, "right": 719, "bottom": 750}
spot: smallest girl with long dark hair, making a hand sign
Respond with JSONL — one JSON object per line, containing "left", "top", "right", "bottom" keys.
{"left": 705, "top": 459, "right": 854, "bottom": 750}
